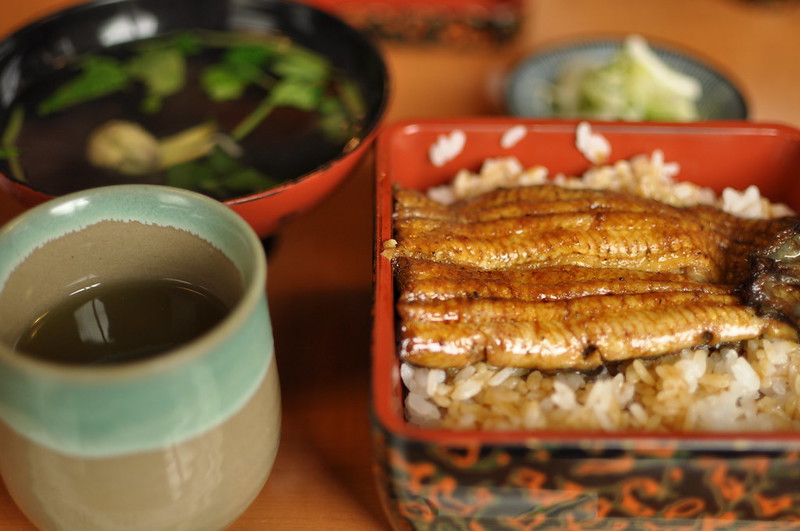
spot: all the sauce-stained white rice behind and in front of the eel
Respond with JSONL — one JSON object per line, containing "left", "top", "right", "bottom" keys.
{"left": 401, "top": 131, "right": 800, "bottom": 432}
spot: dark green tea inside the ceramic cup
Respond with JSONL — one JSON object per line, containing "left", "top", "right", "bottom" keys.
{"left": 15, "top": 279, "right": 230, "bottom": 365}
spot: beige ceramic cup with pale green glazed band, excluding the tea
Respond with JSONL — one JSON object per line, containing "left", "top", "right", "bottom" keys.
{"left": 0, "top": 185, "right": 280, "bottom": 531}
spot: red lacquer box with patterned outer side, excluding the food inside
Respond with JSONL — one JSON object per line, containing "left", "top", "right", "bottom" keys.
{"left": 372, "top": 117, "right": 800, "bottom": 530}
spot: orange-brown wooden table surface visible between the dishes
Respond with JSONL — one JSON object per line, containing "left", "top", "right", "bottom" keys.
{"left": 0, "top": 0, "right": 800, "bottom": 531}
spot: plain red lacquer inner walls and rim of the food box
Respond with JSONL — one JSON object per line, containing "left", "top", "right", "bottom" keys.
{"left": 372, "top": 117, "right": 800, "bottom": 443}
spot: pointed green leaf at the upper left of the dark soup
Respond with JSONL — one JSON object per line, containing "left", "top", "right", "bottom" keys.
{"left": 37, "top": 55, "right": 131, "bottom": 115}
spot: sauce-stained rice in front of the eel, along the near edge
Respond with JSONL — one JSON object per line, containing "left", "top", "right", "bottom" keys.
{"left": 403, "top": 340, "right": 800, "bottom": 431}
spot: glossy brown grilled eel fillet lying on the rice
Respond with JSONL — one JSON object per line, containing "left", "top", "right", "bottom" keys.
{"left": 384, "top": 185, "right": 798, "bottom": 370}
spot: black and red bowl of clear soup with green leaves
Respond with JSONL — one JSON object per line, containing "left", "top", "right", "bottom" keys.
{"left": 0, "top": 0, "right": 389, "bottom": 237}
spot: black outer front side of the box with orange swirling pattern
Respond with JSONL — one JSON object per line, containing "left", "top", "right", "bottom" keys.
{"left": 374, "top": 428, "right": 800, "bottom": 531}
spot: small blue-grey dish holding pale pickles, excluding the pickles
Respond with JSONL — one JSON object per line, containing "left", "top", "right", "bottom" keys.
{"left": 505, "top": 38, "right": 748, "bottom": 120}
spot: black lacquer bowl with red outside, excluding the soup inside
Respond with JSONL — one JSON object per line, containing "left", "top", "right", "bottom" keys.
{"left": 0, "top": 0, "right": 389, "bottom": 237}
